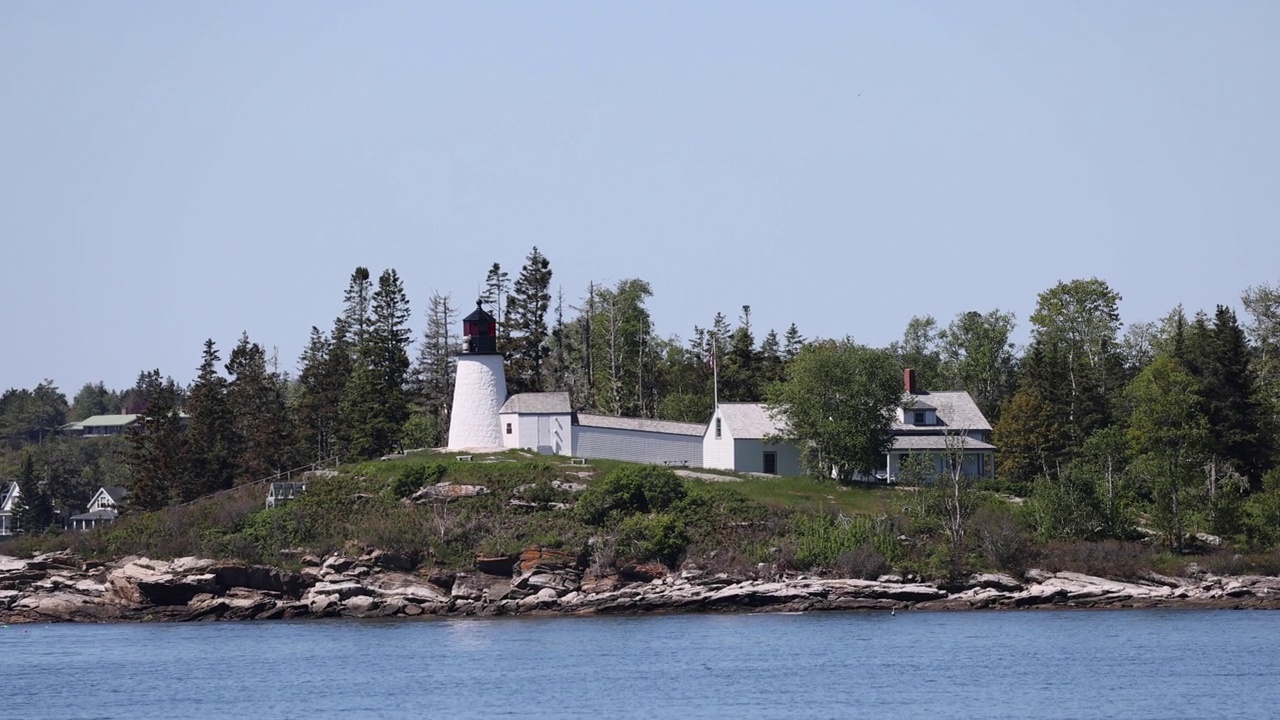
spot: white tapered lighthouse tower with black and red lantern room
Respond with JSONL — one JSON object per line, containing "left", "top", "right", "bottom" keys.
{"left": 449, "top": 300, "right": 507, "bottom": 450}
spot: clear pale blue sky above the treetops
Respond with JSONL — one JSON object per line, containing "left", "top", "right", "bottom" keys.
{"left": 0, "top": 0, "right": 1280, "bottom": 396}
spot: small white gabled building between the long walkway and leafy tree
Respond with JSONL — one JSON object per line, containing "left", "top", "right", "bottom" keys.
{"left": 701, "top": 402, "right": 800, "bottom": 475}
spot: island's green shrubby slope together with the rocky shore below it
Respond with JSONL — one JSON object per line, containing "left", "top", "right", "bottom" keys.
{"left": 0, "top": 451, "right": 1280, "bottom": 623}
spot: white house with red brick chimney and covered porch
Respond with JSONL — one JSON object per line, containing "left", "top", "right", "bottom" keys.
{"left": 877, "top": 369, "right": 996, "bottom": 482}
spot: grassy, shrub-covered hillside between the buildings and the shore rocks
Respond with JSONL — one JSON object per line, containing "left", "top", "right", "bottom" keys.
{"left": 10, "top": 452, "right": 1280, "bottom": 578}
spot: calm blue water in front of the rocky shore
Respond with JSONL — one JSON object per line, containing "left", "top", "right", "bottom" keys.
{"left": 0, "top": 611, "right": 1280, "bottom": 720}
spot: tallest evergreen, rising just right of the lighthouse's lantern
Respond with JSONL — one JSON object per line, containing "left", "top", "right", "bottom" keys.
{"left": 503, "top": 247, "right": 552, "bottom": 393}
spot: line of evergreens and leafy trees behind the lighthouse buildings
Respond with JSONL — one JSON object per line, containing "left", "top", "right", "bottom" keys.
{"left": 0, "top": 254, "right": 1280, "bottom": 542}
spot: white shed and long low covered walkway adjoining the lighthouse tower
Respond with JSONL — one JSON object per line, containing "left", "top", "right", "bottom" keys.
{"left": 498, "top": 392, "right": 705, "bottom": 468}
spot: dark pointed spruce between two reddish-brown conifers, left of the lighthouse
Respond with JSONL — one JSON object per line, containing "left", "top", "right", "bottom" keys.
{"left": 179, "top": 340, "right": 238, "bottom": 500}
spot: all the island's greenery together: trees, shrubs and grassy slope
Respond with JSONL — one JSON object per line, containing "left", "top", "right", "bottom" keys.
{"left": 0, "top": 266, "right": 1280, "bottom": 616}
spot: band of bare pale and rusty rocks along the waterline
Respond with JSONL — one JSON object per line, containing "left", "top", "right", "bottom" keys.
{"left": 0, "top": 548, "right": 1280, "bottom": 623}
